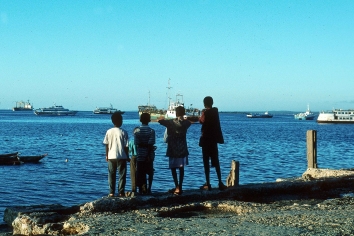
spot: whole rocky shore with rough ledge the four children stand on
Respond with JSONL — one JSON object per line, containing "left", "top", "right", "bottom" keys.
{"left": 0, "top": 169, "right": 354, "bottom": 235}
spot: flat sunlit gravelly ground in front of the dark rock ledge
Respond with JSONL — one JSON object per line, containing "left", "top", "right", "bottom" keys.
{"left": 59, "top": 197, "right": 354, "bottom": 235}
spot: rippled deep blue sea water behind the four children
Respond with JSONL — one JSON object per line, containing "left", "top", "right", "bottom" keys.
{"left": 0, "top": 110, "right": 354, "bottom": 222}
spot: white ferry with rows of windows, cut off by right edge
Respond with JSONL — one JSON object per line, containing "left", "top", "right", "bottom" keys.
{"left": 317, "top": 109, "right": 354, "bottom": 124}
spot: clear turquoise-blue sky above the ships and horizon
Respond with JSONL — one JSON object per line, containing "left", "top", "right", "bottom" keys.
{"left": 0, "top": 0, "right": 354, "bottom": 111}
